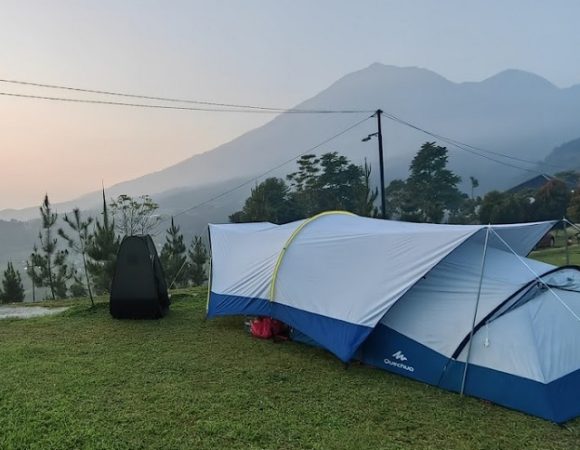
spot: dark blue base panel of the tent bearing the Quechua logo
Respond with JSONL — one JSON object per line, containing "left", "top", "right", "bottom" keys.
{"left": 357, "top": 324, "right": 580, "bottom": 423}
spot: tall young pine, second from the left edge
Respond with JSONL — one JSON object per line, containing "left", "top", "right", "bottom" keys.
{"left": 29, "top": 195, "right": 73, "bottom": 300}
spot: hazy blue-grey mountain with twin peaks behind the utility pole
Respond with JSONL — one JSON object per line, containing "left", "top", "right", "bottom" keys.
{"left": 0, "top": 63, "right": 580, "bottom": 225}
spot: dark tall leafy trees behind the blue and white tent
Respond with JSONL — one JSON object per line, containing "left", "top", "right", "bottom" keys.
{"left": 230, "top": 142, "right": 580, "bottom": 229}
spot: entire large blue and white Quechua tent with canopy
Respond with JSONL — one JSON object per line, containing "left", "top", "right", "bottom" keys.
{"left": 208, "top": 212, "right": 580, "bottom": 423}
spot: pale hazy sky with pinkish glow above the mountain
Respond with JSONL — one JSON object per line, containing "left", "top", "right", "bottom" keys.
{"left": 0, "top": 0, "right": 580, "bottom": 209}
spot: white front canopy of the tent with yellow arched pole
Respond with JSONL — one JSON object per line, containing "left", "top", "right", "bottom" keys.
{"left": 210, "top": 212, "right": 553, "bottom": 361}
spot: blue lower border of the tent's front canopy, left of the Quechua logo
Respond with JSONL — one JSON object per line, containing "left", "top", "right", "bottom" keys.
{"left": 207, "top": 292, "right": 373, "bottom": 362}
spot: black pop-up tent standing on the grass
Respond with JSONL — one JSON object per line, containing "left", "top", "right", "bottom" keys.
{"left": 109, "top": 235, "right": 169, "bottom": 319}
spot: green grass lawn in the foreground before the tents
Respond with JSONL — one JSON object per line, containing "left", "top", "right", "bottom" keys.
{"left": 0, "top": 290, "right": 580, "bottom": 449}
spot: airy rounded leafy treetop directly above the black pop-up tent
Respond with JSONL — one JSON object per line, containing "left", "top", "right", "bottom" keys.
{"left": 111, "top": 194, "right": 161, "bottom": 236}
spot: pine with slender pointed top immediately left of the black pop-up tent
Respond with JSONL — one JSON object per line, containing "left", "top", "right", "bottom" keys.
{"left": 86, "top": 189, "right": 120, "bottom": 294}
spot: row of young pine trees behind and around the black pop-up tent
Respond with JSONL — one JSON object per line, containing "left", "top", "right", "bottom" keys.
{"left": 0, "top": 192, "right": 208, "bottom": 305}
